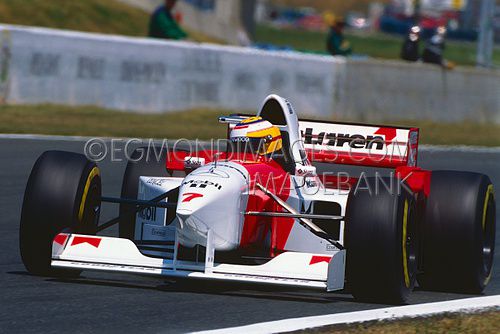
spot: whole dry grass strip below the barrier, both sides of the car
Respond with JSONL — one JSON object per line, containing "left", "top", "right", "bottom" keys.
{"left": 0, "top": 105, "right": 500, "bottom": 146}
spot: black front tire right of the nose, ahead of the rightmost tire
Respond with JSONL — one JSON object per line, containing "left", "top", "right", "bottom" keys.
{"left": 345, "top": 177, "right": 418, "bottom": 304}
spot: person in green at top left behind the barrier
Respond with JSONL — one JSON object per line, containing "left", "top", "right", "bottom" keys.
{"left": 149, "top": 0, "right": 187, "bottom": 39}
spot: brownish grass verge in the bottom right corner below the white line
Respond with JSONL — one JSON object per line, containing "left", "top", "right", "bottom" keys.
{"left": 312, "top": 311, "right": 500, "bottom": 334}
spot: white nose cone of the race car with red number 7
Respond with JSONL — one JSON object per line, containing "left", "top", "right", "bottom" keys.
{"left": 176, "top": 165, "right": 247, "bottom": 250}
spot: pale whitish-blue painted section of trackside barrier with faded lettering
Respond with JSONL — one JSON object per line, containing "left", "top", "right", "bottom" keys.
{"left": 0, "top": 26, "right": 345, "bottom": 115}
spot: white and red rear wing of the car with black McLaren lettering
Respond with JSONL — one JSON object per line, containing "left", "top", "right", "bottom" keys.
{"left": 299, "top": 120, "right": 419, "bottom": 168}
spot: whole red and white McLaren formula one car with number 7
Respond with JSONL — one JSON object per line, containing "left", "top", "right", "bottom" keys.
{"left": 20, "top": 95, "right": 496, "bottom": 303}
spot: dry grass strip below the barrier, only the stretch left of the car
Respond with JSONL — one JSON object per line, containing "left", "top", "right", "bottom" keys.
{"left": 0, "top": 105, "right": 226, "bottom": 139}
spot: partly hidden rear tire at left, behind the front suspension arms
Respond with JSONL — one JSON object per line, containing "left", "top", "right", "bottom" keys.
{"left": 118, "top": 147, "right": 171, "bottom": 240}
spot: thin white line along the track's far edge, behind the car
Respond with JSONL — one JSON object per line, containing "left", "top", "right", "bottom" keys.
{"left": 0, "top": 133, "right": 500, "bottom": 154}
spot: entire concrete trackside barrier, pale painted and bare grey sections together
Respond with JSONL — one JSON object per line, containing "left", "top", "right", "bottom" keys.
{"left": 0, "top": 25, "right": 500, "bottom": 124}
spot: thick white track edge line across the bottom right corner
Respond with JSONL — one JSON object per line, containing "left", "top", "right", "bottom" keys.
{"left": 198, "top": 295, "right": 500, "bottom": 334}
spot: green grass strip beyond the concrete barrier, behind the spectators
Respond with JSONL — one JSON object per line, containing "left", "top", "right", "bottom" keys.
{"left": 255, "top": 26, "right": 500, "bottom": 65}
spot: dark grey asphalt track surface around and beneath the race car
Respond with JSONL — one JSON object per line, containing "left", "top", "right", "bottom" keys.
{"left": 0, "top": 139, "right": 500, "bottom": 333}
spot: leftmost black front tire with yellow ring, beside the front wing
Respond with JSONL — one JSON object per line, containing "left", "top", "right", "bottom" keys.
{"left": 19, "top": 151, "right": 101, "bottom": 276}
